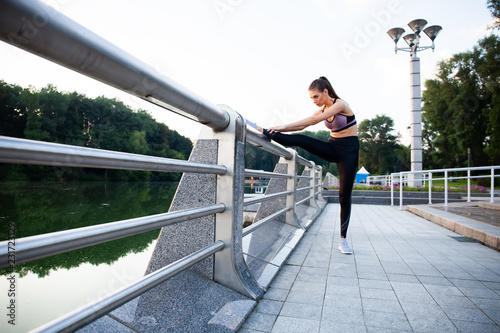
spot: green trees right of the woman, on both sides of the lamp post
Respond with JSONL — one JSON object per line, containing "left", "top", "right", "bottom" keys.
{"left": 358, "top": 0, "right": 500, "bottom": 174}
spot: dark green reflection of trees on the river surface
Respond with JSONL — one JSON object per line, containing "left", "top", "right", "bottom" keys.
{"left": 0, "top": 182, "right": 178, "bottom": 277}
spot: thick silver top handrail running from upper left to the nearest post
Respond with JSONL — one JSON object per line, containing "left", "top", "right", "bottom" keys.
{"left": 0, "top": 0, "right": 229, "bottom": 130}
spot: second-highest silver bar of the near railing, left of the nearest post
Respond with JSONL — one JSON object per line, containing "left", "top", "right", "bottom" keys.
{"left": 0, "top": 136, "right": 227, "bottom": 175}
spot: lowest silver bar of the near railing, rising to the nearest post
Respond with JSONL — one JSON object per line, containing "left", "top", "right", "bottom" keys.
{"left": 33, "top": 241, "right": 224, "bottom": 333}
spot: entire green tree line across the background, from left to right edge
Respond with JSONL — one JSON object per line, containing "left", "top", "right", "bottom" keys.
{"left": 0, "top": 0, "right": 500, "bottom": 181}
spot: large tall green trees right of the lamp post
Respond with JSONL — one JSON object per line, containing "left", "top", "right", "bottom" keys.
{"left": 422, "top": 35, "right": 500, "bottom": 169}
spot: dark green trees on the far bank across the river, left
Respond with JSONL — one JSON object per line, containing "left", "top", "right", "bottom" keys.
{"left": 0, "top": 80, "right": 192, "bottom": 181}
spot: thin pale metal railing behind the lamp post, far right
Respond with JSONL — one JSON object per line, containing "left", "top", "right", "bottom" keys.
{"left": 390, "top": 166, "right": 500, "bottom": 210}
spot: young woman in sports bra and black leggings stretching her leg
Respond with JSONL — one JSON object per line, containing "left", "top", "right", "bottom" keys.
{"left": 263, "top": 76, "right": 359, "bottom": 254}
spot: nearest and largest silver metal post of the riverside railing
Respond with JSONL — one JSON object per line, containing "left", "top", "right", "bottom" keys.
{"left": 198, "top": 105, "right": 264, "bottom": 299}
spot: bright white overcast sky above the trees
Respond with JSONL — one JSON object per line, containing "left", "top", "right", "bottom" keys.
{"left": 0, "top": 0, "right": 492, "bottom": 145}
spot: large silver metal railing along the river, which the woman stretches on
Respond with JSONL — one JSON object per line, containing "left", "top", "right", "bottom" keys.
{"left": 0, "top": 0, "right": 322, "bottom": 332}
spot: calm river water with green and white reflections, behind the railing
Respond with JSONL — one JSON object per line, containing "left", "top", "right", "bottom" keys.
{"left": 0, "top": 182, "right": 178, "bottom": 332}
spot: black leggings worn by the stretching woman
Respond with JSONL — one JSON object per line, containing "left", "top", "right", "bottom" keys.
{"left": 264, "top": 130, "right": 359, "bottom": 238}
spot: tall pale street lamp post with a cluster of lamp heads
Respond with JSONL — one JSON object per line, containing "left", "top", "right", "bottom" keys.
{"left": 387, "top": 19, "right": 442, "bottom": 187}
